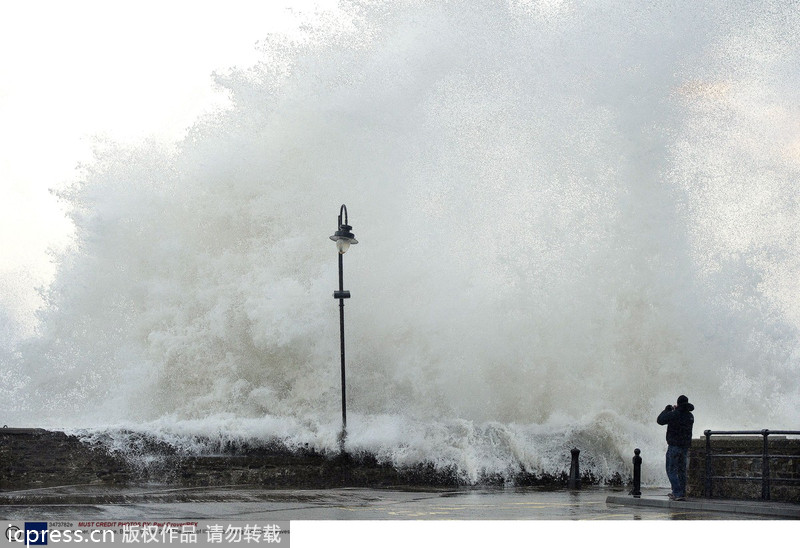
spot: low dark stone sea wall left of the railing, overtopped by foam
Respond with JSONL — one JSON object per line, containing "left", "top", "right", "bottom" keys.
{"left": 0, "top": 428, "right": 597, "bottom": 490}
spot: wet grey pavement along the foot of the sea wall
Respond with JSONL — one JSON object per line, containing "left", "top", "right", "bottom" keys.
{"left": 0, "top": 486, "right": 788, "bottom": 521}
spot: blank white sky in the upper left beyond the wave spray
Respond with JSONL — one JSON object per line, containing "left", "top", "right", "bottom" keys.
{"left": 0, "top": 0, "right": 336, "bottom": 336}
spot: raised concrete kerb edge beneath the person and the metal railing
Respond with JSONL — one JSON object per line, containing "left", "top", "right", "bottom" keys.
{"left": 606, "top": 495, "right": 800, "bottom": 519}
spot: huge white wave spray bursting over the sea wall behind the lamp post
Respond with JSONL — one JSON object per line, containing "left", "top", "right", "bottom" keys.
{"left": 0, "top": 0, "right": 800, "bottom": 481}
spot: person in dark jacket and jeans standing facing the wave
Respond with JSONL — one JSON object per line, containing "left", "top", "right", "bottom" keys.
{"left": 656, "top": 396, "right": 694, "bottom": 500}
